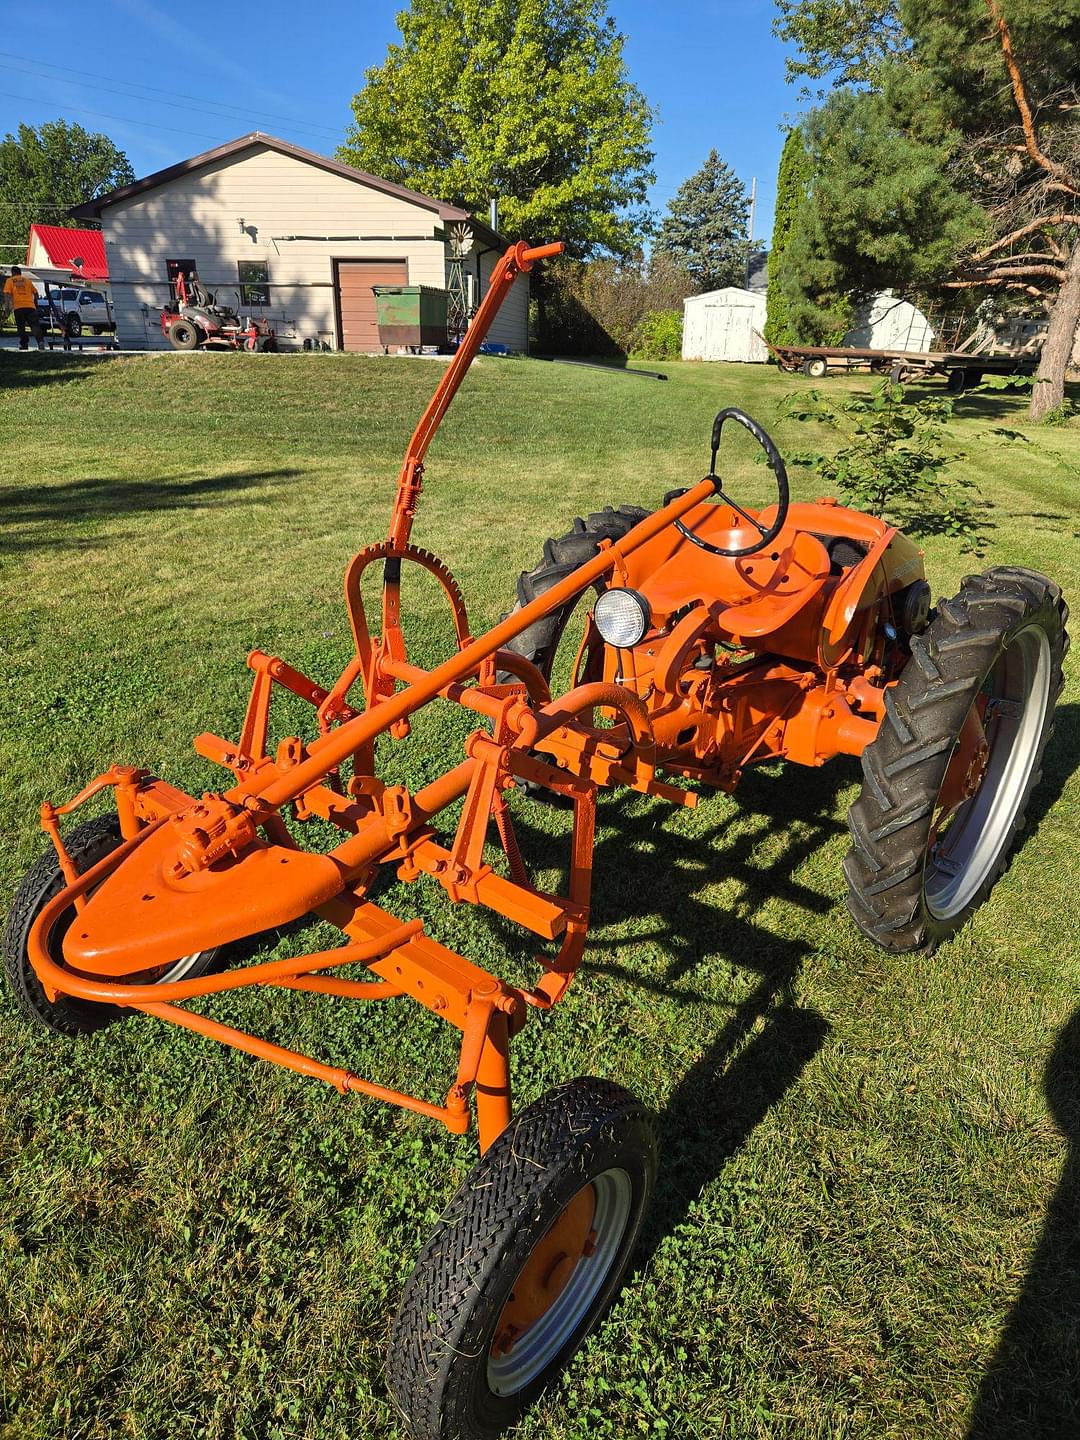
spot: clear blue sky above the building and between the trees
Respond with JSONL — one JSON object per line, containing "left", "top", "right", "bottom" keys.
{"left": 0, "top": 0, "right": 796, "bottom": 239}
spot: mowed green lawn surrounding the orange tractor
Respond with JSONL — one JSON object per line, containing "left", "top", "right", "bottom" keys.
{"left": 0, "top": 354, "right": 1080, "bottom": 1440}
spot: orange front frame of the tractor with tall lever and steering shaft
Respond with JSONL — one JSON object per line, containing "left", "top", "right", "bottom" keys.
{"left": 29, "top": 245, "right": 711, "bottom": 1148}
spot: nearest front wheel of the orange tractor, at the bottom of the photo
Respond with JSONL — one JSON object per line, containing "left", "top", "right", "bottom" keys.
{"left": 387, "top": 1079, "right": 657, "bottom": 1440}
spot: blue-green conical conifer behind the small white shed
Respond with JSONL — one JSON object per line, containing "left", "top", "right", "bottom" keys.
{"left": 654, "top": 150, "right": 749, "bottom": 294}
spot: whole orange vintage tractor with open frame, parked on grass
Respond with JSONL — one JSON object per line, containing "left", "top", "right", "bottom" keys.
{"left": 6, "top": 243, "right": 1067, "bottom": 1440}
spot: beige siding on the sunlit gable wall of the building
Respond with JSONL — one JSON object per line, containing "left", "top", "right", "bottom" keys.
{"left": 102, "top": 145, "right": 446, "bottom": 348}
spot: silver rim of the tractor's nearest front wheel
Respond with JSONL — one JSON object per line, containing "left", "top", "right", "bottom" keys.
{"left": 487, "top": 1168, "right": 634, "bottom": 1395}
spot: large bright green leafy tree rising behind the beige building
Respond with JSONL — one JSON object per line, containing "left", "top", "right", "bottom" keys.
{"left": 338, "top": 0, "right": 654, "bottom": 256}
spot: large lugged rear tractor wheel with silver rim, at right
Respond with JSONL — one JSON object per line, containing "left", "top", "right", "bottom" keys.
{"left": 844, "top": 566, "right": 1068, "bottom": 950}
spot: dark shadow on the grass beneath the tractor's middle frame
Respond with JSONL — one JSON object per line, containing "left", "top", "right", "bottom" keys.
{"left": 514, "top": 762, "right": 858, "bottom": 1269}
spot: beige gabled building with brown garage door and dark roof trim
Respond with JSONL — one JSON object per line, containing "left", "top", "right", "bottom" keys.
{"left": 72, "top": 132, "right": 528, "bottom": 353}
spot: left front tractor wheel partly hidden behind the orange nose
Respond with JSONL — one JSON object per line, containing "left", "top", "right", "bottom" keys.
{"left": 4, "top": 815, "right": 217, "bottom": 1040}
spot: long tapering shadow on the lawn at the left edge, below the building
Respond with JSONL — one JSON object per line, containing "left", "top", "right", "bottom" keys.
{"left": 0, "top": 467, "right": 304, "bottom": 554}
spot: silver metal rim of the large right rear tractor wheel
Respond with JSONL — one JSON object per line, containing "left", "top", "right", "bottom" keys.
{"left": 923, "top": 625, "right": 1051, "bottom": 920}
